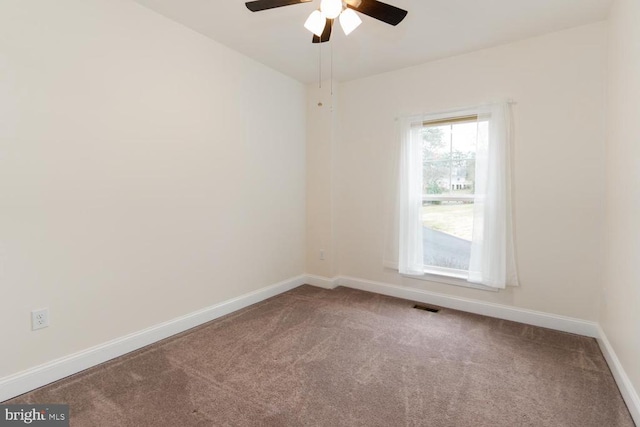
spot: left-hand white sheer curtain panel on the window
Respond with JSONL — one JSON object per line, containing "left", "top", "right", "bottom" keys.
{"left": 397, "top": 116, "right": 424, "bottom": 275}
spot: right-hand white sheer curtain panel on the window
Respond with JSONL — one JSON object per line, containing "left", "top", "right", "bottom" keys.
{"left": 468, "top": 102, "right": 518, "bottom": 289}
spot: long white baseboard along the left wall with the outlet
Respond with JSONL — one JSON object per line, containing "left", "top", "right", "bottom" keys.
{"left": 0, "top": 276, "right": 307, "bottom": 402}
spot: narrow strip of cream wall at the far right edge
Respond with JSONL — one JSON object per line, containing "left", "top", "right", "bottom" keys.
{"left": 600, "top": 0, "right": 640, "bottom": 404}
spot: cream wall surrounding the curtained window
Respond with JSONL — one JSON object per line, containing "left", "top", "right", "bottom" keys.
{"left": 307, "top": 23, "right": 606, "bottom": 320}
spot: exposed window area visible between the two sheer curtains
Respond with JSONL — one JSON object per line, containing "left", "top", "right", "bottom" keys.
{"left": 421, "top": 115, "right": 487, "bottom": 277}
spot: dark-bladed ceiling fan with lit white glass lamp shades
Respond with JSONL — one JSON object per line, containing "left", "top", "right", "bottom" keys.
{"left": 245, "top": 0, "right": 408, "bottom": 43}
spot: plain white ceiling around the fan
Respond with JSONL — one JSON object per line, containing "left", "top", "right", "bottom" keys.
{"left": 136, "top": 0, "right": 611, "bottom": 83}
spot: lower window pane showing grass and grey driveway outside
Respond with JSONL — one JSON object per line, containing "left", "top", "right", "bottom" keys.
{"left": 422, "top": 201, "right": 473, "bottom": 270}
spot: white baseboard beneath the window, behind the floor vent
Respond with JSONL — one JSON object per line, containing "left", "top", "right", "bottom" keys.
{"left": 334, "top": 277, "right": 598, "bottom": 338}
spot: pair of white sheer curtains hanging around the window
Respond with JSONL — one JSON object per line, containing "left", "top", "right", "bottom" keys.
{"left": 384, "top": 102, "right": 518, "bottom": 288}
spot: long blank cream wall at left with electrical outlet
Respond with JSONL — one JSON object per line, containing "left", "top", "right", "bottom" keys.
{"left": 0, "top": 0, "right": 306, "bottom": 378}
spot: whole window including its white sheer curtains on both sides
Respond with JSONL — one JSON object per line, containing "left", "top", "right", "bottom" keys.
{"left": 390, "top": 103, "right": 517, "bottom": 288}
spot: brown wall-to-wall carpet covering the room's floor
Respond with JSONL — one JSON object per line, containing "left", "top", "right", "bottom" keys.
{"left": 6, "top": 286, "right": 634, "bottom": 427}
